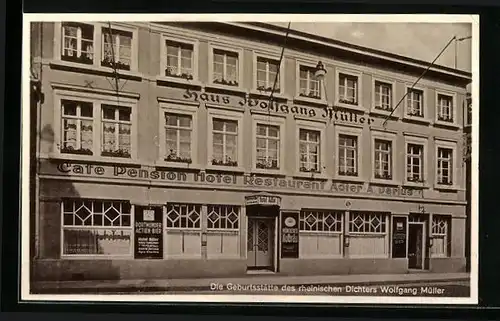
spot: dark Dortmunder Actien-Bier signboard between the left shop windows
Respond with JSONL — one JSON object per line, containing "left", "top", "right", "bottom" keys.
{"left": 134, "top": 206, "right": 163, "bottom": 259}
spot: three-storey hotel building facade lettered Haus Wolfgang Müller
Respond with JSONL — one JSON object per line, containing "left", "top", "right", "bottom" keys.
{"left": 30, "top": 22, "right": 471, "bottom": 280}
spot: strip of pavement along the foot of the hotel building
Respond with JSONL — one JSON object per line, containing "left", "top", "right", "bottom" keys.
{"left": 31, "top": 273, "right": 470, "bottom": 294}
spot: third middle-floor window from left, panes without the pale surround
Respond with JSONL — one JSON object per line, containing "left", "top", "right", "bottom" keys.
{"left": 165, "top": 112, "right": 193, "bottom": 163}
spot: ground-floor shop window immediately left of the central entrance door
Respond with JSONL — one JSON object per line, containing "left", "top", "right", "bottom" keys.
{"left": 207, "top": 205, "right": 240, "bottom": 258}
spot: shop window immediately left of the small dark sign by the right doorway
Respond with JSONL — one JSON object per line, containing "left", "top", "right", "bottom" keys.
{"left": 349, "top": 212, "right": 389, "bottom": 257}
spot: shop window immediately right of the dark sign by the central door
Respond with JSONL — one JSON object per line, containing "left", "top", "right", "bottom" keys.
{"left": 299, "top": 210, "right": 344, "bottom": 258}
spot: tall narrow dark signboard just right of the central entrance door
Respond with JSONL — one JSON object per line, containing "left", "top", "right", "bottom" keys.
{"left": 281, "top": 212, "right": 299, "bottom": 259}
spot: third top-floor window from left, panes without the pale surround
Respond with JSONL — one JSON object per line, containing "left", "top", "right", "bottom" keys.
{"left": 165, "top": 40, "right": 194, "bottom": 80}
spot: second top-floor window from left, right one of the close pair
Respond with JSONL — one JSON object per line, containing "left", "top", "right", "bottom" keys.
{"left": 101, "top": 28, "right": 132, "bottom": 70}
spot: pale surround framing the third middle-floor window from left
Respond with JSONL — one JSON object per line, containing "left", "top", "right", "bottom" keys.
{"left": 158, "top": 101, "right": 199, "bottom": 168}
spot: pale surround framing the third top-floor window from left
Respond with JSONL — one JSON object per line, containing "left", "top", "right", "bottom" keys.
{"left": 159, "top": 33, "right": 199, "bottom": 83}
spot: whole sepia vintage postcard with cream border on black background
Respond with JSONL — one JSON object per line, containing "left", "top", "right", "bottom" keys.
{"left": 20, "top": 14, "right": 479, "bottom": 304}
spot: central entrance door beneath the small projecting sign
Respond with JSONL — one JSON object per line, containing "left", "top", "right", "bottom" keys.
{"left": 247, "top": 217, "right": 274, "bottom": 270}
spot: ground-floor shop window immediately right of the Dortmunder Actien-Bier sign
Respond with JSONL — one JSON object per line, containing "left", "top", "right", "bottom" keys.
{"left": 165, "top": 203, "right": 202, "bottom": 257}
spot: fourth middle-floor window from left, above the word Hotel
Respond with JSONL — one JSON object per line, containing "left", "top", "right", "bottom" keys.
{"left": 212, "top": 118, "right": 238, "bottom": 166}
